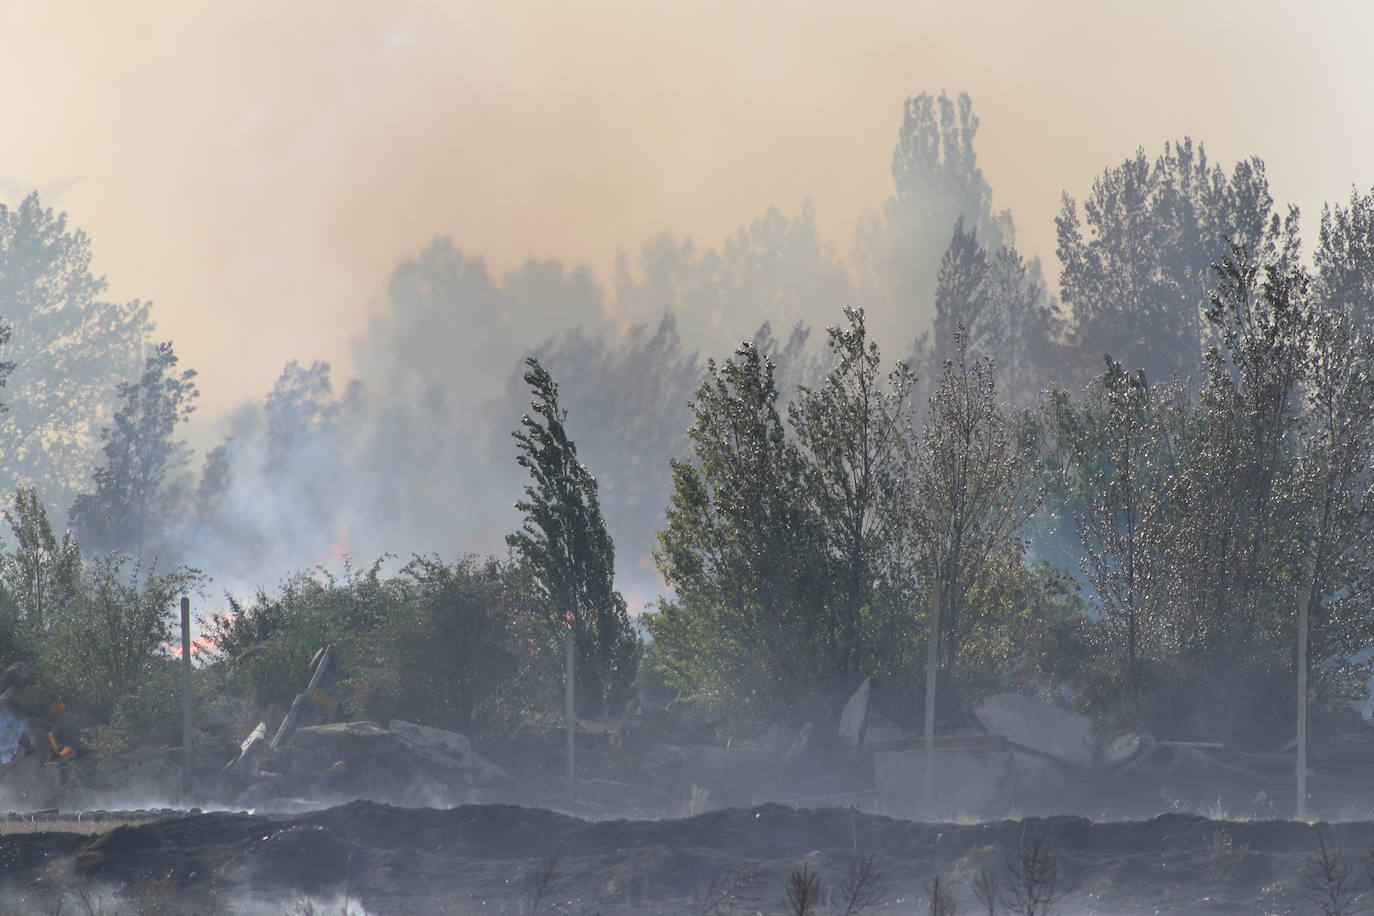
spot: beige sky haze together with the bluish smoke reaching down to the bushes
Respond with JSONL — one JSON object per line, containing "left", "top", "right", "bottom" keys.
{"left": 0, "top": 3, "right": 1374, "bottom": 600}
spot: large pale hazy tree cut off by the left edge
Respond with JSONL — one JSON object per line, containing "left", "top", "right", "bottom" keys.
{"left": 0, "top": 194, "right": 153, "bottom": 519}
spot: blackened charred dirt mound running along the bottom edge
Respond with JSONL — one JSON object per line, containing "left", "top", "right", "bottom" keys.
{"left": 0, "top": 802, "right": 1374, "bottom": 913}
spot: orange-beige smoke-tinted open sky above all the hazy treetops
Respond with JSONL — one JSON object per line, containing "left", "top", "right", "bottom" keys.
{"left": 0, "top": 0, "right": 1374, "bottom": 412}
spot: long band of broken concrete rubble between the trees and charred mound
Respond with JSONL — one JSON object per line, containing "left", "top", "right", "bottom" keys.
{"left": 0, "top": 647, "right": 1374, "bottom": 818}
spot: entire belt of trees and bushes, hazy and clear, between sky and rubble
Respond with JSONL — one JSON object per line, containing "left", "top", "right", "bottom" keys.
{"left": 0, "top": 96, "right": 1374, "bottom": 743}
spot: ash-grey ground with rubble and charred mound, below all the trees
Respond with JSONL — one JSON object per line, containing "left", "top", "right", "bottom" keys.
{"left": 0, "top": 661, "right": 1374, "bottom": 916}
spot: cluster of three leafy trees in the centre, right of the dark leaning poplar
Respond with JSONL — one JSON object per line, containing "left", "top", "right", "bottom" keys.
{"left": 646, "top": 309, "right": 1036, "bottom": 725}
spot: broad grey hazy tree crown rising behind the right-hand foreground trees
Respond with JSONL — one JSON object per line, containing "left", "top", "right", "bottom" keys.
{"left": 1055, "top": 139, "right": 1297, "bottom": 380}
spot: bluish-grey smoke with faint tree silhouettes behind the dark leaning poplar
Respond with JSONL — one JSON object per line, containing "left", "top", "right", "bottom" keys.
{"left": 142, "top": 95, "right": 1013, "bottom": 608}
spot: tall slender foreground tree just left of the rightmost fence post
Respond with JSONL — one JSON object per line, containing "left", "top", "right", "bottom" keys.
{"left": 1168, "top": 247, "right": 1314, "bottom": 666}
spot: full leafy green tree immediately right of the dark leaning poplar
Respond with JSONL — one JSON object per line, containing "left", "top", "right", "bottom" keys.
{"left": 646, "top": 343, "right": 835, "bottom": 721}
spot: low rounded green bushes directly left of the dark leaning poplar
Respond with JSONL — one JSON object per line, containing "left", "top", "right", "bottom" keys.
{"left": 207, "top": 558, "right": 561, "bottom": 735}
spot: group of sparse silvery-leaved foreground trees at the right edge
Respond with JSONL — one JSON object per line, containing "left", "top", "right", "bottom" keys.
{"left": 1051, "top": 249, "right": 1374, "bottom": 737}
